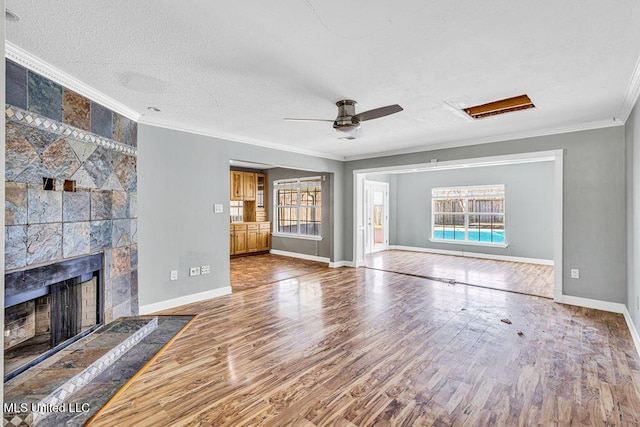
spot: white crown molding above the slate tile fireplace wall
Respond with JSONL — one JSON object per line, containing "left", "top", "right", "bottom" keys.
{"left": 4, "top": 40, "right": 140, "bottom": 122}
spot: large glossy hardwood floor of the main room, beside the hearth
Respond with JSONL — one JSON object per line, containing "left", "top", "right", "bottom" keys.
{"left": 93, "top": 268, "right": 640, "bottom": 427}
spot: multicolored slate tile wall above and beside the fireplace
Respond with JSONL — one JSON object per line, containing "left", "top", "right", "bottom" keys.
{"left": 5, "top": 60, "right": 138, "bottom": 322}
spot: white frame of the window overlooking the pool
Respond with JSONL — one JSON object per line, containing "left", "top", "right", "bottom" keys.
{"left": 429, "top": 184, "right": 509, "bottom": 248}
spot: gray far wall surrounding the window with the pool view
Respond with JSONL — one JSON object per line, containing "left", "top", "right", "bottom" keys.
{"left": 390, "top": 162, "right": 554, "bottom": 260}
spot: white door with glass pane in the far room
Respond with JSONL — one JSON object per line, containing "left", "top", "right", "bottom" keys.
{"left": 365, "top": 181, "right": 389, "bottom": 254}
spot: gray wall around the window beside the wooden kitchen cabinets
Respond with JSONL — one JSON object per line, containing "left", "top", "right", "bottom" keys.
{"left": 269, "top": 168, "right": 334, "bottom": 258}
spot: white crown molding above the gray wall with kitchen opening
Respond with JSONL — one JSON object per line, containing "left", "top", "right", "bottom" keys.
{"left": 138, "top": 114, "right": 345, "bottom": 162}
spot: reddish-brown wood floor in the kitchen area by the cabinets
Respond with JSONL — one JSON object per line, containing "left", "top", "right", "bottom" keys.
{"left": 231, "top": 254, "right": 327, "bottom": 291}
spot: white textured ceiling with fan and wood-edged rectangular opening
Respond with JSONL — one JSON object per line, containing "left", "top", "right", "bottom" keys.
{"left": 6, "top": 0, "right": 640, "bottom": 159}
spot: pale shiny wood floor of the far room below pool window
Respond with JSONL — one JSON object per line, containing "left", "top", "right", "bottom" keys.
{"left": 366, "top": 250, "right": 553, "bottom": 298}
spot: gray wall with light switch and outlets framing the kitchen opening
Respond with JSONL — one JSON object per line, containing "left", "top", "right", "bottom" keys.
{"left": 138, "top": 125, "right": 344, "bottom": 306}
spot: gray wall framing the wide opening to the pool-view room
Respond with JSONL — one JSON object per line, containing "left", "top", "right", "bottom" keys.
{"left": 344, "top": 126, "right": 627, "bottom": 303}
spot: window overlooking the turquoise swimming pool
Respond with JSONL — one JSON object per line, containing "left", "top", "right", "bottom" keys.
{"left": 431, "top": 185, "right": 506, "bottom": 246}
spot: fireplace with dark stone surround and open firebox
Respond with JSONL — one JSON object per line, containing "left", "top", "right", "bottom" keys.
{"left": 4, "top": 254, "right": 103, "bottom": 382}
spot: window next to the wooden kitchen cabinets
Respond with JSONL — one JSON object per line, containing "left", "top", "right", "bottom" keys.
{"left": 273, "top": 177, "right": 322, "bottom": 238}
